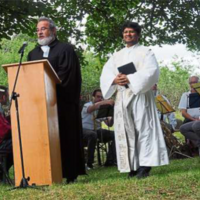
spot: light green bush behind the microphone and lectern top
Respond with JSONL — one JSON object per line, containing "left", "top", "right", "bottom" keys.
{"left": 0, "top": 35, "right": 36, "bottom": 86}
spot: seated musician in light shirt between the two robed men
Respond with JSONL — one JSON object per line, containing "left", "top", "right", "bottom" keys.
{"left": 81, "top": 89, "right": 116, "bottom": 168}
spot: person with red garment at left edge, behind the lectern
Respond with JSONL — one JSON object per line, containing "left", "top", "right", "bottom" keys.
{"left": 0, "top": 86, "right": 13, "bottom": 182}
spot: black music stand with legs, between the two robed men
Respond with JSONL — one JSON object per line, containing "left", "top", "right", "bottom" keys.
{"left": 95, "top": 104, "right": 114, "bottom": 166}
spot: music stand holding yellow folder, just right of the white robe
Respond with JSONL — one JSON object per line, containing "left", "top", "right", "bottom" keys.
{"left": 155, "top": 95, "right": 175, "bottom": 120}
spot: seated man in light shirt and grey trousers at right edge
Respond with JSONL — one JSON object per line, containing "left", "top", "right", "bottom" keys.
{"left": 178, "top": 76, "right": 200, "bottom": 155}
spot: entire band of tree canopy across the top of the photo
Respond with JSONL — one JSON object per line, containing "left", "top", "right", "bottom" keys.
{"left": 0, "top": 0, "right": 200, "bottom": 56}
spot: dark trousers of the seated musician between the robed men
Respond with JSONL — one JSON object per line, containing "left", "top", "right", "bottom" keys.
{"left": 83, "top": 129, "right": 116, "bottom": 164}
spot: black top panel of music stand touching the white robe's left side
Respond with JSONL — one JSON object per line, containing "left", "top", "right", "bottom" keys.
{"left": 96, "top": 104, "right": 114, "bottom": 119}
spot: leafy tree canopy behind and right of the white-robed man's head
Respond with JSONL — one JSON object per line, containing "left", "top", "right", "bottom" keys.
{"left": 83, "top": 0, "right": 200, "bottom": 56}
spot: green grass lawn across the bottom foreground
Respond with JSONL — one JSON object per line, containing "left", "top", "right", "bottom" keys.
{"left": 0, "top": 157, "right": 200, "bottom": 200}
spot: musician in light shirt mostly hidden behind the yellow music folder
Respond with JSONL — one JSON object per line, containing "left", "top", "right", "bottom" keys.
{"left": 151, "top": 84, "right": 177, "bottom": 133}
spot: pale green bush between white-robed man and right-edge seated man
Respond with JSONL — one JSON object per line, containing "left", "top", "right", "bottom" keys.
{"left": 158, "top": 61, "right": 197, "bottom": 108}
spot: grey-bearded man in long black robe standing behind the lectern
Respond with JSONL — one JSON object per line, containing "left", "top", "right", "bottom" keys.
{"left": 28, "top": 17, "right": 85, "bottom": 183}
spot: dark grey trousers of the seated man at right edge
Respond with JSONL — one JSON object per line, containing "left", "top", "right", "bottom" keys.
{"left": 180, "top": 121, "right": 200, "bottom": 148}
